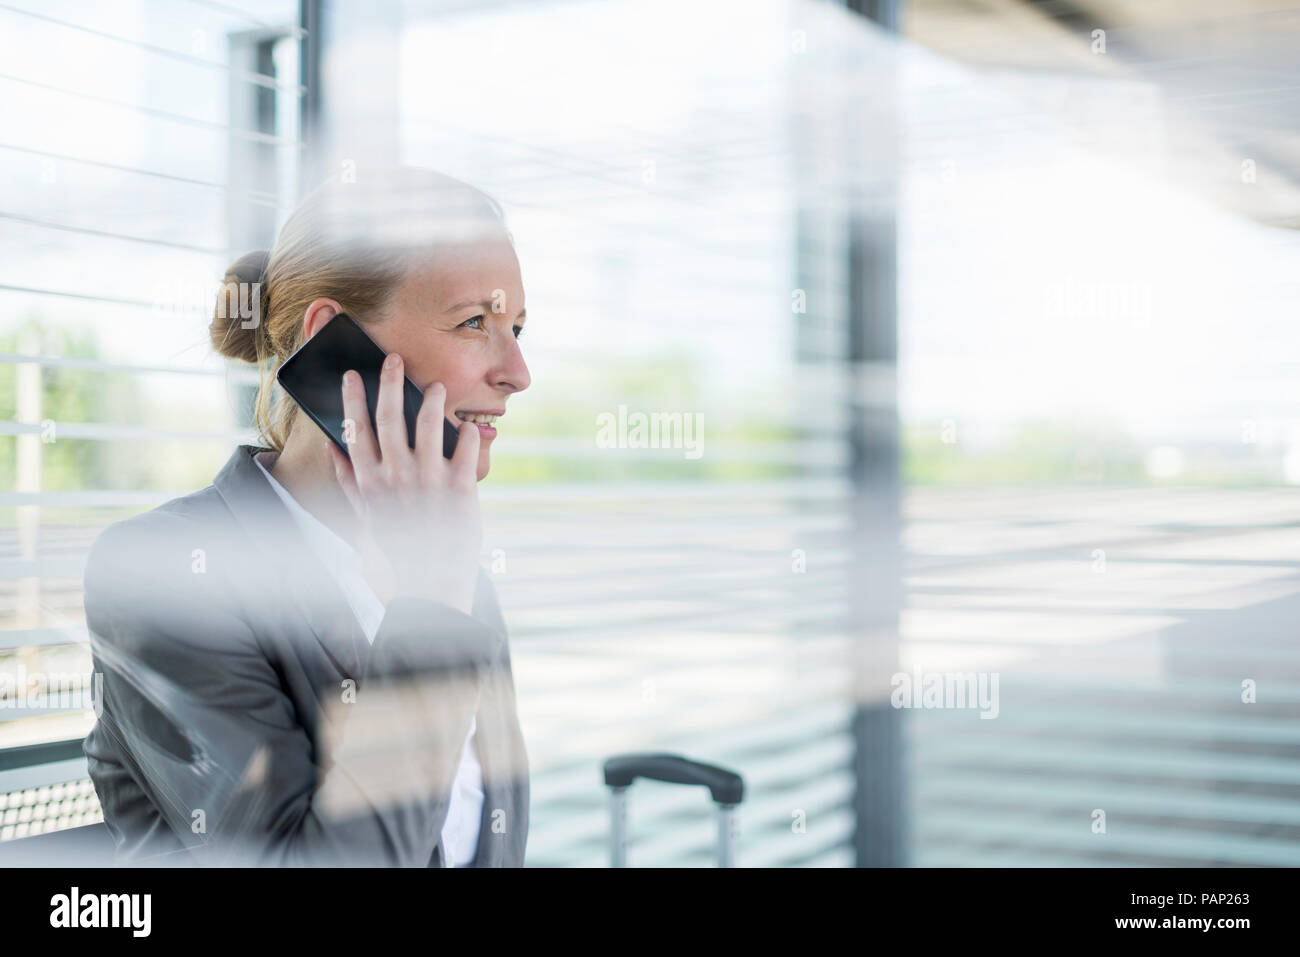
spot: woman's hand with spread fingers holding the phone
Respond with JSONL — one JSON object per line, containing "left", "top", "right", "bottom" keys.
{"left": 326, "top": 352, "right": 482, "bottom": 615}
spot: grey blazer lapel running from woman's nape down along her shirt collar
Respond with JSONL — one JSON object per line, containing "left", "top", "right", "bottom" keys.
{"left": 212, "top": 445, "right": 369, "bottom": 677}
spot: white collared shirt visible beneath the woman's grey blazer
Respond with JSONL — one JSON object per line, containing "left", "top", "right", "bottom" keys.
{"left": 252, "top": 452, "right": 484, "bottom": 867}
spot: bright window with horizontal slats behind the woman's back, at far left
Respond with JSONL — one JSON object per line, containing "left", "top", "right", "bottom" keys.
{"left": 0, "top": 1, "right": 306, "bottom": 840}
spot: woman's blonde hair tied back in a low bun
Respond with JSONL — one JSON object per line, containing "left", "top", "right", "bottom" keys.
{"left": 208, "top": 166, "right": 511, "bottom": 450}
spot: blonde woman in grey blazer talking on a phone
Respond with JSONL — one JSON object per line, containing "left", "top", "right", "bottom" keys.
{"left": 78, "top": 169, "right": 529, "bottom": 867}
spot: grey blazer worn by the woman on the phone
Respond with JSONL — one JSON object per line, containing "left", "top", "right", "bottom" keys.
{"left": 85, "top": 445, "right": 529, "bottom": 867}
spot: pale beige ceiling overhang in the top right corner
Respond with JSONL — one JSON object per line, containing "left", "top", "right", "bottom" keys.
{"left": 901, "top": 0, "right": 1300, "bottom": 229}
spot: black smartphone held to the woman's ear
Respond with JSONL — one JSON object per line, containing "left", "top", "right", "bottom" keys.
{"left": 276, "top": 312, "right": 460, "bottom": 459}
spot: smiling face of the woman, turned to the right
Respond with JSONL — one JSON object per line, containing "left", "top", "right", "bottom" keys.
{"left": 367, "top": 237, "right": 532, "bottom": 480}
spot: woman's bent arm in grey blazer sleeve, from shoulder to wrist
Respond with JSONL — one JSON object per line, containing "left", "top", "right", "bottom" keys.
{"left": 86, "top": 521, "right": 504, "bottom": 867}
